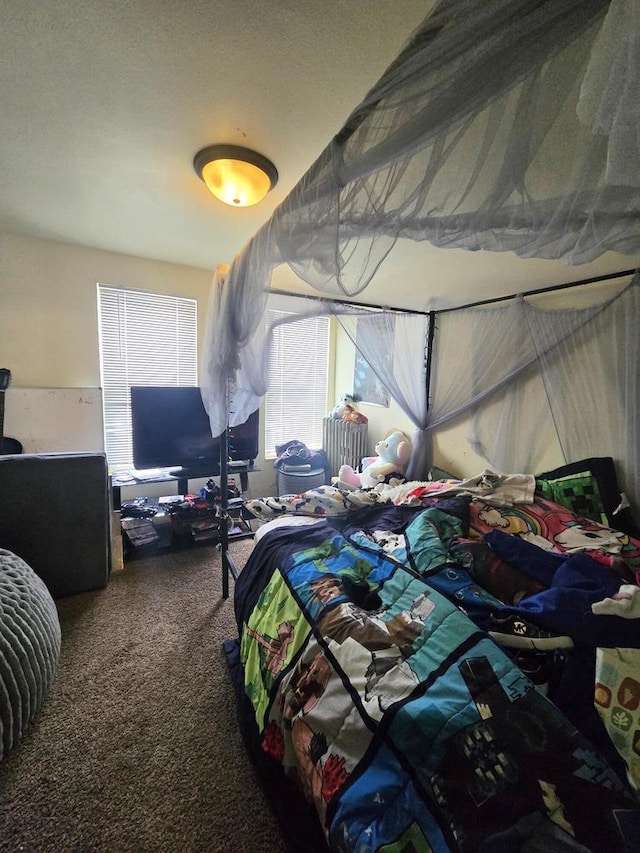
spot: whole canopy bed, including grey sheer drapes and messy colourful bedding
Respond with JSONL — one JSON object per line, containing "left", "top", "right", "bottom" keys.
{"left": 216, "top": 0, "right": 640, "bottom": 853}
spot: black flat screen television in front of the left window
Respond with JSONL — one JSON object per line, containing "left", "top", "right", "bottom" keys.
{"left": 131, "top": 385, "right": 259, "bottom": 475}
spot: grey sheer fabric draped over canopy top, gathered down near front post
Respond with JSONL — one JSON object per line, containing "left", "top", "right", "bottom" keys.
{"left": 203, "top": 0, "right": 640, "bottom": 422}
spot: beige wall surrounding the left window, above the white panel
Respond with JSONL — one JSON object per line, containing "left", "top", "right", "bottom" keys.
{"left": 0, "top": 228, "right": 212, "bottom": 388}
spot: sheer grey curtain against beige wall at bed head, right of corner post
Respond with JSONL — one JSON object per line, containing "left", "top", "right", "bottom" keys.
{"left": 429, "top": 273, "right": 640, "bottom": 512}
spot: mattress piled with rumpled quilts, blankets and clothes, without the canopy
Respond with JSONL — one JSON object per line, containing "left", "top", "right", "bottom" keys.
{"left": 225, "top": 471, "right": 640, "bottom": 853}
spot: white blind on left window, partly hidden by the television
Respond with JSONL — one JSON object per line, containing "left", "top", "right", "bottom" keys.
{"left": 98, "top": 284, "right": 198, "bottom": 470}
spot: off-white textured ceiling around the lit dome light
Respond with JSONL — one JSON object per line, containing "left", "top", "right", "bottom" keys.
{"left": 0, "top": 0, "right": 640, "bottom": 308}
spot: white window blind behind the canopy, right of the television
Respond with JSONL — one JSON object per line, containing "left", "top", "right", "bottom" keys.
{"left": 264, "top": 309, "right": 329, "bottom": 455}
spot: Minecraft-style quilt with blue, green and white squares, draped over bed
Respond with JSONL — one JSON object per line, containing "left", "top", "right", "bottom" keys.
{"left": 230, "top": 499, "right": 640, "bottom": 853}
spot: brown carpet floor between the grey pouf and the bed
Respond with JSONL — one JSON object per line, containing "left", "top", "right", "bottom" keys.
{"left": 0, "top": 540, "right": 287, "bottom": 853}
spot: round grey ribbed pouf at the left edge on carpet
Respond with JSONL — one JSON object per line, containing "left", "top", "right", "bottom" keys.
{"left": 0, "top": 548, "right": 60, "bottom": 760}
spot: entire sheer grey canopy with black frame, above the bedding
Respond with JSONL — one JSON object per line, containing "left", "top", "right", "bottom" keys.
{"left": 199, "top": 0, "right": 640, "bottom": 568}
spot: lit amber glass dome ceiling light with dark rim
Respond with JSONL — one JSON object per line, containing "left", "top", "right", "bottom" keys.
{"left": 193, "top": 145, "right": 278, "bottom": 207}
